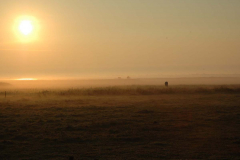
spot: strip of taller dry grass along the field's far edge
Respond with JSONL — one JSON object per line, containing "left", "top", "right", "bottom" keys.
{"left": 0, "top": 85, "right": 240, "bottom": 96}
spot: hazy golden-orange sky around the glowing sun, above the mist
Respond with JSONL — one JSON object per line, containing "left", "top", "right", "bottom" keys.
{"left": 0, "top": 0, "right": 240, "bottom": 79}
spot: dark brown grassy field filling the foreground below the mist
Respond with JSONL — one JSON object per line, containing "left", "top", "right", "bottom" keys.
{"left": 0, "top": 85, "right": 240, "bottom": 160}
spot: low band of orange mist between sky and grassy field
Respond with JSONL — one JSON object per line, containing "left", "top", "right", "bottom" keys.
{"left": 0, "top": 77, "right": 240, "bottom": 88}
